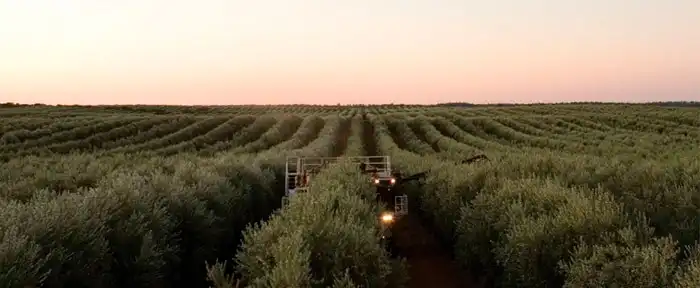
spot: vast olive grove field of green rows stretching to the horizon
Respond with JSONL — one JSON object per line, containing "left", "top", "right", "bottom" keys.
{"left": 0, "top": 104, "right": 700, "bottom": 287}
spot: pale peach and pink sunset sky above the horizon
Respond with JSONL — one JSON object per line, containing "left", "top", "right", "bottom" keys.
{"left": 0, "top": 0, "right": 700, "bottom": 105}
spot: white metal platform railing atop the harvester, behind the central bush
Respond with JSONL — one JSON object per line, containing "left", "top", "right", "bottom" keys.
{"left": 284, "top": 156, "right": 391, "bottom": 196}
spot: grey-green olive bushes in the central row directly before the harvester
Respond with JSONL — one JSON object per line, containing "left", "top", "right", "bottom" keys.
{"left": 227, "top": 165, "right": 405, "bottom": 287}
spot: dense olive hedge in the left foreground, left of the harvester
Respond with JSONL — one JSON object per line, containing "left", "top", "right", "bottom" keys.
{"left": 0, "top": 158, "right": 281, "bottom": 287}
